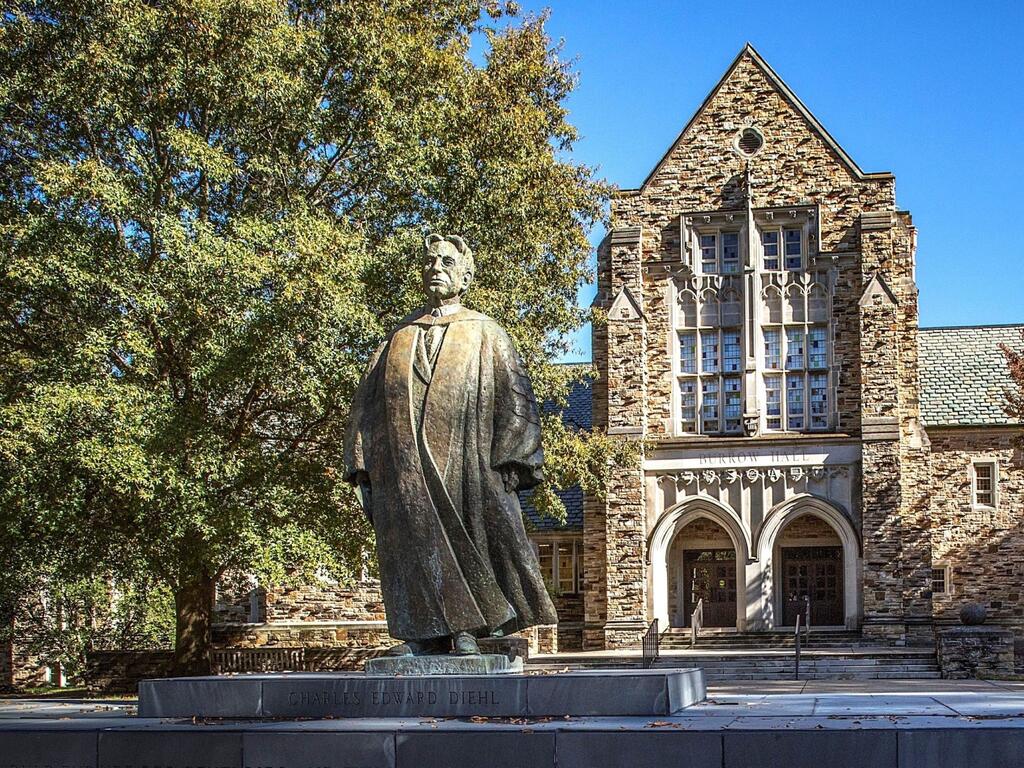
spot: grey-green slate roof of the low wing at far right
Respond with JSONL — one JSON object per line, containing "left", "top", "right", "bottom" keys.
{"left": 918, "top": 325, "right": 1024, "bottom": 427}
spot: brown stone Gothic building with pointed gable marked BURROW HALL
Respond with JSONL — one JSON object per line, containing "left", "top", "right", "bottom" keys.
{"left": 582, "top": 46, "right": 1024, "bottom": 648}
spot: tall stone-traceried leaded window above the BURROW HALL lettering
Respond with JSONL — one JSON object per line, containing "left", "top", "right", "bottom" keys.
{"left": 674, "top": 205, "right": 836, "bottom": 435}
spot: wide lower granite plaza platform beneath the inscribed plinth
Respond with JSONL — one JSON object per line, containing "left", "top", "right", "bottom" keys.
{"left": 9, "top": 694, "right": 1024, "bottom": 768}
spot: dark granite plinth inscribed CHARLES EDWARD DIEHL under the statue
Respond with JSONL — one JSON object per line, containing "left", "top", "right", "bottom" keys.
{"left": 138, "top": 669, "right": 707, "bottom": 719}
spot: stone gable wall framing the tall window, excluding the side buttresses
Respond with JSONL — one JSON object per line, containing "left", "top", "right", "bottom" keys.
{"left": 611, "top": 56, "right": 895, "bottom": 437}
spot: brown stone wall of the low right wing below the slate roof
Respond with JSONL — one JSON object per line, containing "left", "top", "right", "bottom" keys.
{"left": 928, "top": 427, "right": 1024, "bottom": 636}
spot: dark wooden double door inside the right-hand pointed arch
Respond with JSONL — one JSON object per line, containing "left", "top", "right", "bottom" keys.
{"left": 782, "top": 547, "right": 846, "bottom": 627}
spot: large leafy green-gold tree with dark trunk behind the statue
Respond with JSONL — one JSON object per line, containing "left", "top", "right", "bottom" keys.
{"left": 0, "top": 0, "right": 626, "bottom": 673}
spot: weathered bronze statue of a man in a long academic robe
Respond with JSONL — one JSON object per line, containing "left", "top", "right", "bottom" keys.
{"left": 345, "top": 234, "right": 557, "bottom": 655}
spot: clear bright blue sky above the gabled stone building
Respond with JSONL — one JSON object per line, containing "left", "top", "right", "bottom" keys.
{"left": 499, "top": 0, "right": 1024, "bottom": 359}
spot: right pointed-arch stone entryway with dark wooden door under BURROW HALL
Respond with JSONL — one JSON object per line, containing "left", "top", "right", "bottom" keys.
{"left": 758, "top": 497, "right": 860, "bottom": 629}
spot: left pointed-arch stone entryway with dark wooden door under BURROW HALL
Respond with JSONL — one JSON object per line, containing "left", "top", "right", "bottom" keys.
{"left": 647, "top": 498, "right": 751, "bottom": 630}
